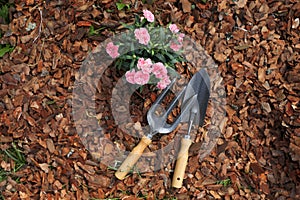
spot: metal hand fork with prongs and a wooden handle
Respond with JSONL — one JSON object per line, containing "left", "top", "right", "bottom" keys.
{"left": 115, "top": 79, "right": 196, "bottom": 180}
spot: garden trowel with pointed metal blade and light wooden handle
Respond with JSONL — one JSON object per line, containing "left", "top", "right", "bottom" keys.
{"left": 172, "top": 69, "right": 210, "bottom": 188}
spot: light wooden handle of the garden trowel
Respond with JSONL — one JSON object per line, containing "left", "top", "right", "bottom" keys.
{"left": 172, "top": 138, "right": 192, "bottom": 188}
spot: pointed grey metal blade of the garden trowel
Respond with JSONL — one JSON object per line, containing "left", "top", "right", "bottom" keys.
{"left": 181, "top": 69, "right": 210, "bottom": 126}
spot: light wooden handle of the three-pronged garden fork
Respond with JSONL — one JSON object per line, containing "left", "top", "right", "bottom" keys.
{"left": 115, "top": 136, "right": 151, "bottom": 180}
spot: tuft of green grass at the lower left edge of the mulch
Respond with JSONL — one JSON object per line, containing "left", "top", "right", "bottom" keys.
{"left": 0, "top": 143, "right": 26, "bottom": 182}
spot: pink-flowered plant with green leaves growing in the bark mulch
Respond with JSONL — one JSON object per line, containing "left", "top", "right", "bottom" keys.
{"left": 106, "top": 10, "right": 185, "bottom": 89}
